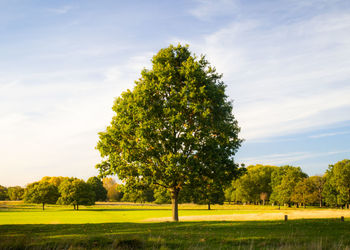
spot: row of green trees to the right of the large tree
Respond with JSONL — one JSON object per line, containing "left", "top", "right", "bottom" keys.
{"left": 225, "top": 159, "right": 350, "bottom": 208}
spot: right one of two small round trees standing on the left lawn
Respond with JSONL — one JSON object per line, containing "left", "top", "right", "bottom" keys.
{"left": 57, "top": 179, "right": 95, "bottom": 210}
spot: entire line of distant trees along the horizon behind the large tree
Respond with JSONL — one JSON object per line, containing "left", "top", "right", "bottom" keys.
{"left": 0, "top": 159, "right": 350, "bottom": 209}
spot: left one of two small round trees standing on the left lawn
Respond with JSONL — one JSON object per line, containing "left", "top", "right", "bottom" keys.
{"left": 24, "top": 182, "right": 60, "bottom": 210}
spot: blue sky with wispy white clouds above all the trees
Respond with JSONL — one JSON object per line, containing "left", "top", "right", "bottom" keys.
{"left": 0, "top": 0, "right": 350, "bottom": 186}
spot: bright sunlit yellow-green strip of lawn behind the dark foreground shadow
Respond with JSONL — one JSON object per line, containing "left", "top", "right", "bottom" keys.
{"left": 0, "top": 202, "right": 277, "bottom": 225}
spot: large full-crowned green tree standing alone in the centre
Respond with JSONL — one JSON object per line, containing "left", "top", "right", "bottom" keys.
{"left": 97, "top": 45, "right": 241, "bottom": 221}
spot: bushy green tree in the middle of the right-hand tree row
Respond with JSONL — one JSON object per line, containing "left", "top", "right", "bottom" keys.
{"left": 270, "top": 166, "right": 308, "bottom": 206}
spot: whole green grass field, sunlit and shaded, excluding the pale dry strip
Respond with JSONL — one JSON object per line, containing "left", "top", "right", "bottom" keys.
{"left": 0, "top": 202, "right": 350, "bottom": 249}
